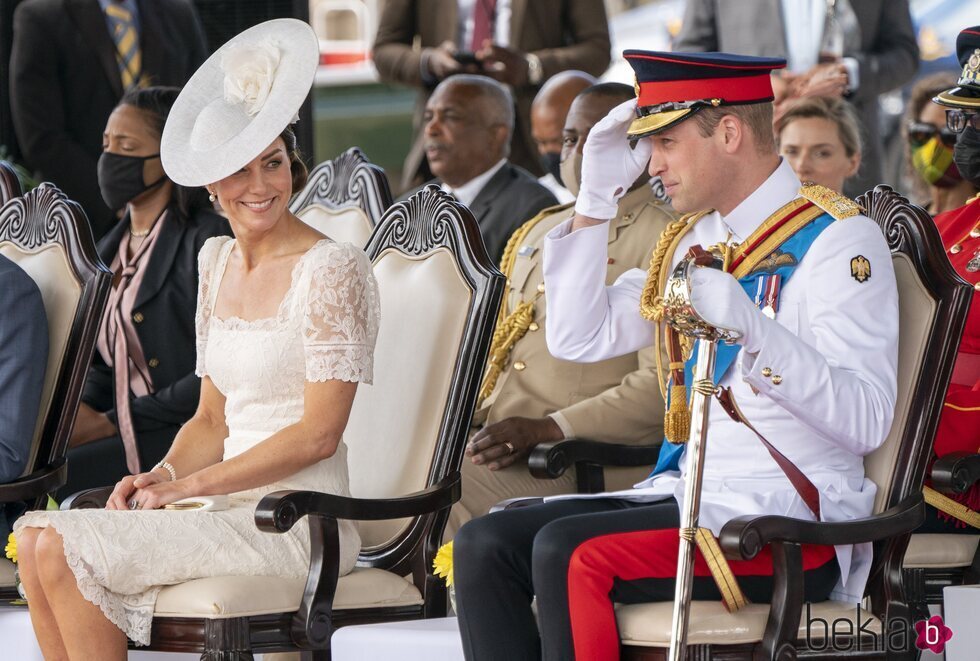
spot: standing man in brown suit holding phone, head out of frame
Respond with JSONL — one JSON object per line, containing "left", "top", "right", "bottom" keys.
{"left": 374, "top": 0, "right": 610, "bottom": 189}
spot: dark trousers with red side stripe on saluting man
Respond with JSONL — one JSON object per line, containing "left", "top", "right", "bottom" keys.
{"left": 453, "top": 498, "right": 839, "bottom": 661}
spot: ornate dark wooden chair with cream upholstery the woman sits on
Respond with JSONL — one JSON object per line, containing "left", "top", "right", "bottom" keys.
{"left": 63, "top": 186, "right": 504, "bottom": 659}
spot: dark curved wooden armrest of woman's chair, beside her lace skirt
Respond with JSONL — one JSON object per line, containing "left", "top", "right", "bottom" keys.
{"left": 255, "top": 471, "right": 462, "bottom": 532}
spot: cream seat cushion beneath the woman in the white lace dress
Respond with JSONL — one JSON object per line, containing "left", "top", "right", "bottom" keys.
{"left": 154, "top": 567, "right": 422, "bottom": 619}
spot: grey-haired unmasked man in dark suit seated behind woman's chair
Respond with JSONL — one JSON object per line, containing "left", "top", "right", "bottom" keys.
{"left": 406, "top": 74, "right": 558, "bottom": 262}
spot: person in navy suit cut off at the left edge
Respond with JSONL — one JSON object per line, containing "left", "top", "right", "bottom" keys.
{"left": 0, "top": 250, "right": 48, "bottom": 542}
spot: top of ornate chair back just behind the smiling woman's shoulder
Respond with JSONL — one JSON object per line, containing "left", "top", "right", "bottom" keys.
{"left": 289, "top": 147, "right": 392, "bottom": 246}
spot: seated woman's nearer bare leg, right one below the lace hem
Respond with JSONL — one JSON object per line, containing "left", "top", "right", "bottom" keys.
{"left": 35, "top": 528, "right": 127, "bottom": 661}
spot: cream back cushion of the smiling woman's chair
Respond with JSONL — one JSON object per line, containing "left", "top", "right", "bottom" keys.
{"left": 344, "top": 248, "right": 471, "bottom": 548}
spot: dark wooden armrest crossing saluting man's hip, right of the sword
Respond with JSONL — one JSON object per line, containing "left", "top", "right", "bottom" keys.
{"left": 719, "top": 493, "right": 926, "bottom": 560}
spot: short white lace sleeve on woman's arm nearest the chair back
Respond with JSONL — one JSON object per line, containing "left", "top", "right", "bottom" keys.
{"left": 303, "top": 242, "right": 380, "bottom": 383}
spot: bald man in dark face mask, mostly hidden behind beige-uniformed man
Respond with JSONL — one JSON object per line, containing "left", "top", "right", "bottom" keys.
{"left": 531, "top": 69, "right": 599, "bottom": 204}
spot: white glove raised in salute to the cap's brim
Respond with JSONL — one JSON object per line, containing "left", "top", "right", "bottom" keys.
{"left": 575, "top": 99, "right": 650, "bottom": 220}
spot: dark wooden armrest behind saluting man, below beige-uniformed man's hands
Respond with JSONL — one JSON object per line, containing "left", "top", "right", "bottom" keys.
{"left": 527, "top": 438, "right": 660, "bottom": 480}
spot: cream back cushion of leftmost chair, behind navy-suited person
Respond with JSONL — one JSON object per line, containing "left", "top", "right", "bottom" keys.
{"left": 0, "top": 241, "right": 82, "bottom": 467}
